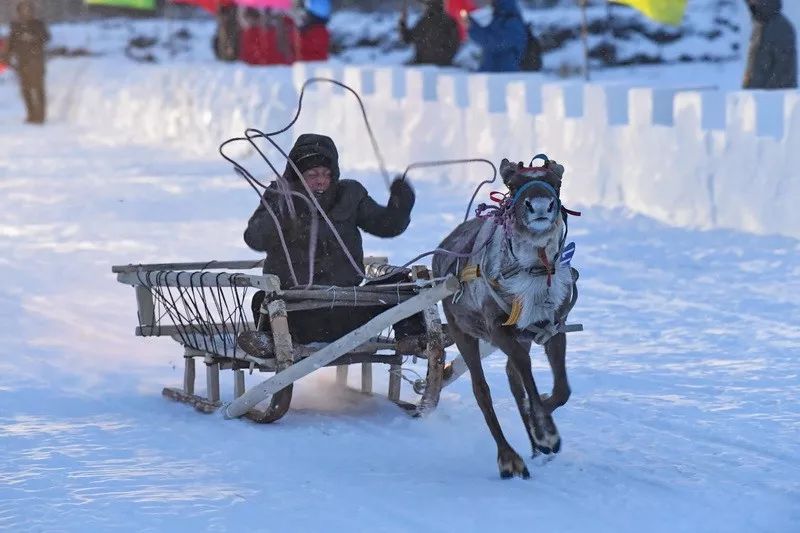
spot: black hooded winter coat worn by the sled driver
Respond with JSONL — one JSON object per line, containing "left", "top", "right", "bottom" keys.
{"left": 244, "top": 135, "right": 414, "bottom": 287}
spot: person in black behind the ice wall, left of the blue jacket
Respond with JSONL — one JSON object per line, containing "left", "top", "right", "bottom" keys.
{"left": 400, "top": 0, "right": 461, "bottom": 66}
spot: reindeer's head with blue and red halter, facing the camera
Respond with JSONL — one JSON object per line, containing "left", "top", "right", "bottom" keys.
{"left": 500, "top": 155, "right": 564, "bottom": 233}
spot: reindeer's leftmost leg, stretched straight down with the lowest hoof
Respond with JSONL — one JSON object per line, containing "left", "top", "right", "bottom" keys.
{"left": 445, "top": 307, "right": 530, "bottom": 479}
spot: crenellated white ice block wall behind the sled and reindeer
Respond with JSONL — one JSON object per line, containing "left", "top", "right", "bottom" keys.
{"left": 50, "top": 59, "right": 800, "bottom": 238}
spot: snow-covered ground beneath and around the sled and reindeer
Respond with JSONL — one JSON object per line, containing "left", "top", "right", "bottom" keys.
{"left": 0, "top": 77, "right": 800, "bottom": 533}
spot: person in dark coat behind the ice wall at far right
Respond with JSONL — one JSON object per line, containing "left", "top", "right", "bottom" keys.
{"left": 742, "top": 0, "right": 797, "bottom": 89}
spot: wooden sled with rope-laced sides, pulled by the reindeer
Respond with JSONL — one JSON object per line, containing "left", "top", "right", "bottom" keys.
{"left": 112, "top": 258, "right": 582, "bottom": 423}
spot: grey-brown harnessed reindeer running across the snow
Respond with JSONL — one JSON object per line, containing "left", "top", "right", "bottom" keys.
{"left": 433, "top": 155, "right": 577, "bottom": 479}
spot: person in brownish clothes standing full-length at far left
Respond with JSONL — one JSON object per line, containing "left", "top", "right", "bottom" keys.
{"left": 5, "top": 0, "right": 50, "bottom": 124}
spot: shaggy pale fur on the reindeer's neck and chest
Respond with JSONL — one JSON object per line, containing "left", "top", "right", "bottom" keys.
{"left": 484, "top": 213, "right": 572, "bottom": 329}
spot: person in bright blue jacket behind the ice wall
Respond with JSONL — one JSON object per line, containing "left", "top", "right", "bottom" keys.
{"left": 469, "top": 0, "right": 528, "bottom": 72}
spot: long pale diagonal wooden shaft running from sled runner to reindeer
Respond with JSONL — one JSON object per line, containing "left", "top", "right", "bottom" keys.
{"left": 225, "top": 276, "right": 460, "bottom": 418}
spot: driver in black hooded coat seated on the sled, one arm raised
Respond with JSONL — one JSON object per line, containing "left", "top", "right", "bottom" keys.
{"left": 244, "top": 134, "right": 415, "bottom": 344}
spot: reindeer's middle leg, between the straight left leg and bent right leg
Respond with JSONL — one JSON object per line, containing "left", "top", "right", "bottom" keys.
{"left": 491, "top": 322, "right": 561, "bottom": 454}
